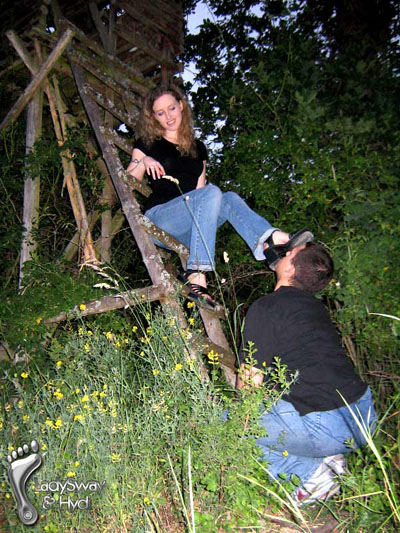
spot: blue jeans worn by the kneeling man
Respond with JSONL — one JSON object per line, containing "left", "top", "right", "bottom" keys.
{"left": 256, "top": 387, "right": 377, "bottom": 483}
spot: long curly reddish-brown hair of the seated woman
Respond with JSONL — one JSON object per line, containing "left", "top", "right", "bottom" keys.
{"left": 138, "top": 84, "right": 196, "bottom": 157}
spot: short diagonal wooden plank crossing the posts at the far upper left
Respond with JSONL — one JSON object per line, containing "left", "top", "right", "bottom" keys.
{"left": 0, "top": 29, "right": 74, "bottom": 131}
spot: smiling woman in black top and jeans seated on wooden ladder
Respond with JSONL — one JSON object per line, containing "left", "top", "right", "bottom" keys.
{"left": 127, "top": 85, "right": 313, "bottom": 308}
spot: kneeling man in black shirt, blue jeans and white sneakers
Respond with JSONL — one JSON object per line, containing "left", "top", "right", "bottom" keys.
{"left": 237, "top": 242, "right": 376, "bottom": 504}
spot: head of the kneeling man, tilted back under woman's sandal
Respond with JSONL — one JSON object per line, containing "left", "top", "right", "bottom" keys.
{"left": 276, "top": 242, "right": 333, "bottom": 294}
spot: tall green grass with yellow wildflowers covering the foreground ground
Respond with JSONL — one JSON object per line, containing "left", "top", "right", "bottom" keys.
{"left": 0, "top": 298, "right": 399, "bottom": 533}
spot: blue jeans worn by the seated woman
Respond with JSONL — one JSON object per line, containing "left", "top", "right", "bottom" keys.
{"left": 145, "top": 184, "right": 277, "bottom": 271}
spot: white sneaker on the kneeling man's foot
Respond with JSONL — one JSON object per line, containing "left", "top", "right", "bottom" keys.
{"left": 294, "top": 461, "right": 340, "bottom": 507}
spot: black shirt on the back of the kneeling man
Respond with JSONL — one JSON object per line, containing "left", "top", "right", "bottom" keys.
{"left": 240, "top": 286, "right": 367, "bottom": 416}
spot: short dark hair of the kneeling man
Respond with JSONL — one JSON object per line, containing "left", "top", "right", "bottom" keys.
{"left": 290, "top": 242, "right": 333, "bottom": 294}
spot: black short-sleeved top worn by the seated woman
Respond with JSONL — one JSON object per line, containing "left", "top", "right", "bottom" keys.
{"left": 135, "top": 137, "right": 208, "bottom": 210}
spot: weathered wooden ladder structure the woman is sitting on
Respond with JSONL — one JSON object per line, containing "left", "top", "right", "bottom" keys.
{"left": 0, "top": 0, "right": 234, "bottom": 382}
